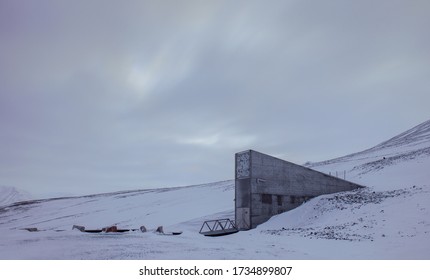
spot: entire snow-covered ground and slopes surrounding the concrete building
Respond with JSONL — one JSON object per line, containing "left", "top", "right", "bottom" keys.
{"left": 0, "top": 121, "right": 430, "bottom": 260}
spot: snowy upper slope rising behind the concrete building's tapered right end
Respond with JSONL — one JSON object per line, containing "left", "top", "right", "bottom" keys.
{"left": 307, "top": 120, "right": 430, "bottom": 190}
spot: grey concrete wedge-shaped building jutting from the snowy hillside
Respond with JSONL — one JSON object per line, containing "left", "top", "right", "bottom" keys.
{"left": 235, "top": 150, "right": 362, "bottom": 230}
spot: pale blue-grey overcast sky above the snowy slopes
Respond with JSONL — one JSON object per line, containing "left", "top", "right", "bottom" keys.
{"left": 0, "top": 0, "right": 430, "bottom": 195}
